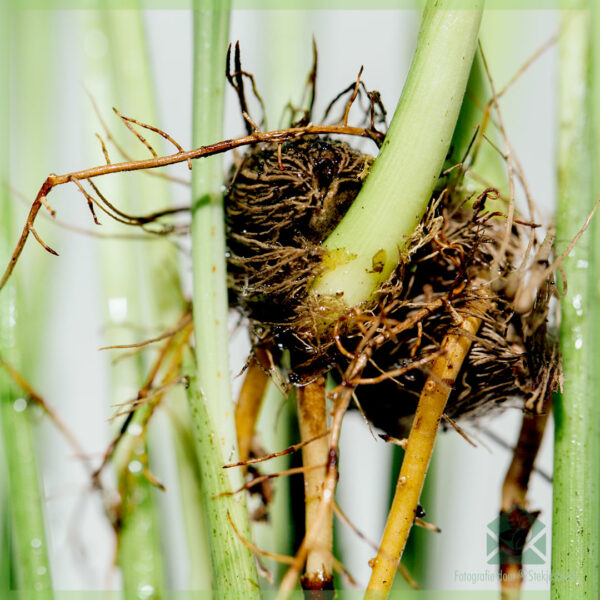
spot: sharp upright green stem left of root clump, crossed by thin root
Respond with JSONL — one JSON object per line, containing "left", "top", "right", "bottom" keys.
{"left": 189, "top": 0, "right": 259, "bottom": 597}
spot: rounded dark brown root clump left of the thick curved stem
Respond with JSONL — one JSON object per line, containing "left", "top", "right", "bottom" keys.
{"left": 226, "top": 136, "right": 373, "bottom": 330}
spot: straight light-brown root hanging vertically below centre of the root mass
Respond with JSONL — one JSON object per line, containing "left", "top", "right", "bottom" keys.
{"left": 298, "top": 377, "right": 333, "bottom": 590}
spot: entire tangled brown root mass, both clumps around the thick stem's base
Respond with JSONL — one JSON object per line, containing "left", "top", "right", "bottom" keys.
{"left": 226, "top": 138, "right": 559, "bottom": 437}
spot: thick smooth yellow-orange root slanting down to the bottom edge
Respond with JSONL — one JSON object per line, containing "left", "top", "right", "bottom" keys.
{"left": 365, "top": 300, "right": 486, "bottom": 600}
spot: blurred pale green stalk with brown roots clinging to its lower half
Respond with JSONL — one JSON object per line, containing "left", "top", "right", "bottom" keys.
{"left": 83, "top": 10, "right": 169, "bottom": 597}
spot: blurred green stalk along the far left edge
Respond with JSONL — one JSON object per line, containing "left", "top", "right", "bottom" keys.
{"left": 0, "top": 5, "right": 53, "bottom": 598}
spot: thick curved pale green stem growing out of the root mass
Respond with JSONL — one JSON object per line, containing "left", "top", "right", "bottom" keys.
{"left": 313, "top": 0, "right": 482, "bottom": 307}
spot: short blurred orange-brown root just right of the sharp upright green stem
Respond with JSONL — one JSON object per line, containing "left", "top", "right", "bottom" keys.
{"left": 235, "top": 348, "right": 269, "bottom": 464}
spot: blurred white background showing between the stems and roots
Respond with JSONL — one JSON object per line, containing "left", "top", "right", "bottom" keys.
{"left": 11, "top": 5, "right": 558, "bottom": 590}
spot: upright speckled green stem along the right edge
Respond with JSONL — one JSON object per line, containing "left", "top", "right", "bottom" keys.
{"left": 551, "top": 11, "right": 600, "bottom": 600}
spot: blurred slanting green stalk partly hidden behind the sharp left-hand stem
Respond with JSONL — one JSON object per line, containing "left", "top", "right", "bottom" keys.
{"left": 104, "top": 10, "right": 216, "bottom": 589}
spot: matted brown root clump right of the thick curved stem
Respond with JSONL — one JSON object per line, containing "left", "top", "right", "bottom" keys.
{"left": 344, "top": 193, "right": 559, "bottom": 437}
